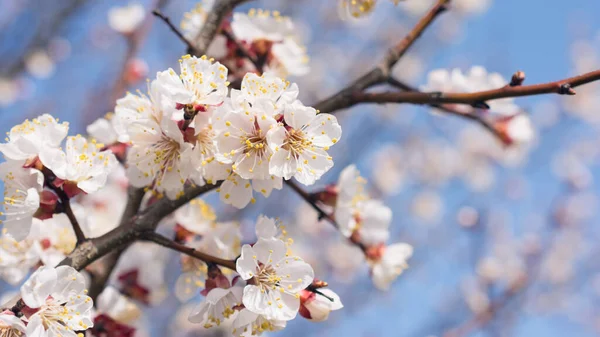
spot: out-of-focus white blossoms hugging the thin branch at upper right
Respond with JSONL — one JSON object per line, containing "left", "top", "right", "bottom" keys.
{"left": 421, "top": 66, "right": 534, "bottom": 145}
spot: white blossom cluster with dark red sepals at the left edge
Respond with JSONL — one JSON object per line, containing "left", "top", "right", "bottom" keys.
{"left": 0, "top": 114, "right": 117, "bottom": 242}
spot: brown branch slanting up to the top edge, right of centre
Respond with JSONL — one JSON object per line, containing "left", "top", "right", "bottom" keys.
{"left": 314, "top": 0, "right": 450, "bottom": 113}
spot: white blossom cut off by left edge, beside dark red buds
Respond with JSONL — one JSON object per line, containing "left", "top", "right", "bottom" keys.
{"left": 0, "top": 160, "right": 44, "bottom": 241}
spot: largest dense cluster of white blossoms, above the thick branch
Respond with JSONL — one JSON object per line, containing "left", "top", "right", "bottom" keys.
{"left": 88, "top": 55, "right": 341, "bottom": 208}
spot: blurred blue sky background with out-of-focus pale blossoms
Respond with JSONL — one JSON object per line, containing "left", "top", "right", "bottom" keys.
{"left": 0, "top": 0, "right": 600, "bottom": 337}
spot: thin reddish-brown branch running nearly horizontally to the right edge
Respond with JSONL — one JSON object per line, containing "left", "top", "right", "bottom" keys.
{"left": 346, "top": 70, "right": 600, "bottom": 107}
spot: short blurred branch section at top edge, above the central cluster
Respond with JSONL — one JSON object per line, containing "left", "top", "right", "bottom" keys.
{"left": 188, "top": 0, "right": 249, "bottom": 56}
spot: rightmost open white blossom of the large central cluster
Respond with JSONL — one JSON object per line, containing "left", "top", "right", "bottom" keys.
{"left": 267, "top": 101, "right": 342, "bottom": 185}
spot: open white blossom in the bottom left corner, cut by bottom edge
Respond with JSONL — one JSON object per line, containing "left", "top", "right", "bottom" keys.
{"left": 21, "top": 266, "right": 93, "bottom": 337}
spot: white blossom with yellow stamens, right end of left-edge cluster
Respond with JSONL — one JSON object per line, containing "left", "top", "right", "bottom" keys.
{"left": 47, "top": 135, "right": 118, "bottom": 193}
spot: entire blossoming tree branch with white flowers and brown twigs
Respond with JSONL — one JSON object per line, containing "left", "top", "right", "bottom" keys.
{"left": 0, "top": 0, "right": 600, "bottom": 337}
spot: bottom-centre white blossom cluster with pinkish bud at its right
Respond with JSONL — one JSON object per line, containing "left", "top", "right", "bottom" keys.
{"left": 183, "top": 216, "right": 342, "bottom": 336}
